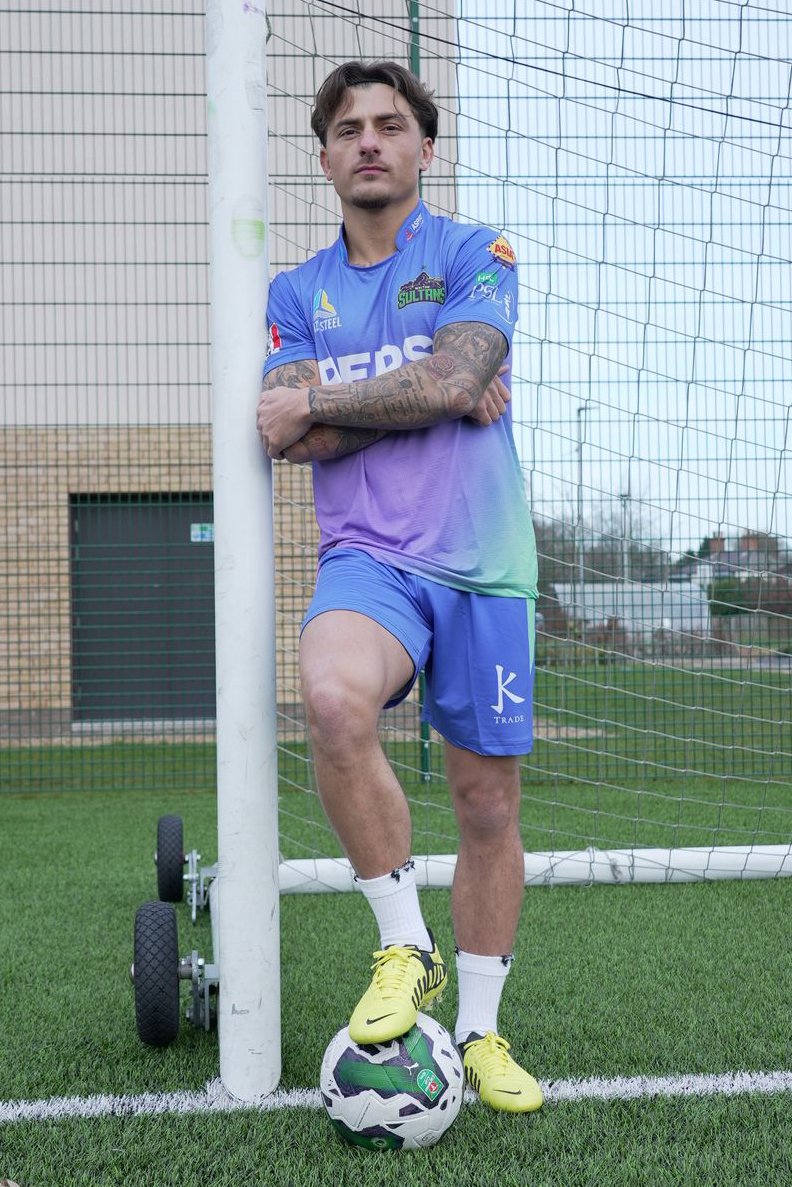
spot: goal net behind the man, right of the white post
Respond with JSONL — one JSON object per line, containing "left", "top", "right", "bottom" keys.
{"left": 268, "top": 0, "right": 792, "bottom": 889}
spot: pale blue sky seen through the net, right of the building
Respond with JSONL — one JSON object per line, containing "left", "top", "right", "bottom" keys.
{"left": 458, "top": 0, "right": 792, "bottom": 552}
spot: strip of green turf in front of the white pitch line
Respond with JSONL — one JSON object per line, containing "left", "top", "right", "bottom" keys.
{"left": 6, "top": 1097, "right": 792, "bottom": 1187}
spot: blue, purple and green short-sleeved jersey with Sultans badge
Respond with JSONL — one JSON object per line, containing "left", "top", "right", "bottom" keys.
{"left": 265, "top": 203, "right": 537, "bottom": 597}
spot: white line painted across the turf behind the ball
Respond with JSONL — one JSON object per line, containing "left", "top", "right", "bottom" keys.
{"left": 0, "top": 1072, "right": 792, "bottom": 1124}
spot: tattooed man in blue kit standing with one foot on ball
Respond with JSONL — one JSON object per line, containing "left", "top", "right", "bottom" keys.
{"left": 258, "top": 62, "right": 541, "bottom": 1112}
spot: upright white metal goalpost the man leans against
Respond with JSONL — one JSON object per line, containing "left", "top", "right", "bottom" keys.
{"left": 205, "top": 0, "right": 280, "bottom": 1103}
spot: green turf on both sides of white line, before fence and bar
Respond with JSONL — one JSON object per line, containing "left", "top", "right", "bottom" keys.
{"left": 0, "top": 791, "right": 792, "bottom": 1187}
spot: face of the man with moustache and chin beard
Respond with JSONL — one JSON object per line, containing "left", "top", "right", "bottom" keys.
{"left": 319, "top": 83, "right": 433, "bottom": 210}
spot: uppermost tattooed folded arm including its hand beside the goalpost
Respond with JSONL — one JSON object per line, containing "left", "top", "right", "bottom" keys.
{"left": 259, "top": 322, "right": 508, "bottom": 457}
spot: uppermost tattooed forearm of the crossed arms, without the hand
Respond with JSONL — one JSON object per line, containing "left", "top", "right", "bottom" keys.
{"left": 308, "top": 322, "right": 508, "bottom": 429}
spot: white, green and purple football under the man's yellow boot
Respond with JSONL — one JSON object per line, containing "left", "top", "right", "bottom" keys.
{"left": 321, "top": 1014, "right": 464, "bottom": 1150}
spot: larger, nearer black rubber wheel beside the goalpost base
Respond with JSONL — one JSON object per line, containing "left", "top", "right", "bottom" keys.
{"left": 134, "top": 902, "right": 179, "bottom": 1047}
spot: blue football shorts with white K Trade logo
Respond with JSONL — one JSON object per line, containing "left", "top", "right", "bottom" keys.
{"left": 303, "top": 548, "right": 536, "bottom": 755}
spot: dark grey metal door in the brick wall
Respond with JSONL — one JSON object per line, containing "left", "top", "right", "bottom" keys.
{"left": 70, "top": 494, "right": 215, "bottom": 722}
